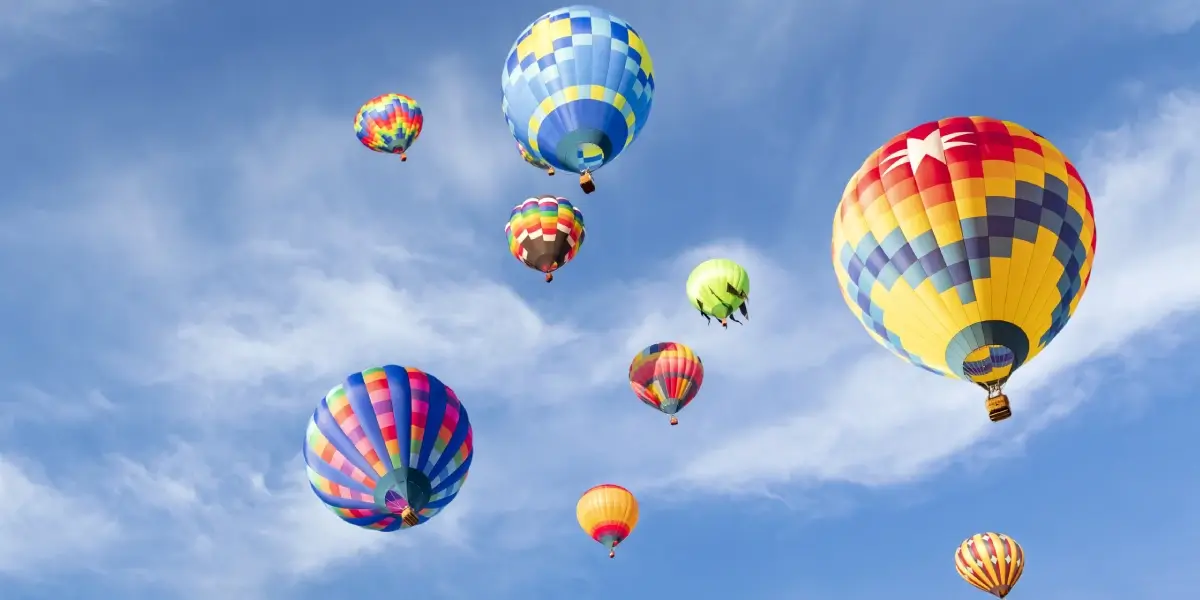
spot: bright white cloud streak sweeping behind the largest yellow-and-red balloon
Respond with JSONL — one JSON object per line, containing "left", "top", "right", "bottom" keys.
{"left": 682, "top": 92, "right": 1200, "bottom": 486}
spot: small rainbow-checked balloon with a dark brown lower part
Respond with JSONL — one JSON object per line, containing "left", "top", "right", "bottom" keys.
{"left": 504, "top": 196, "right": 587, "bottom": 282}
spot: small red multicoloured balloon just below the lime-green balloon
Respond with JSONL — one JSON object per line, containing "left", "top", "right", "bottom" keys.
{"left": 629, "top": 342, "right": 704, "bottom": 425}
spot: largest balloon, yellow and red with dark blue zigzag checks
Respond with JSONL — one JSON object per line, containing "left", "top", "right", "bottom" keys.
{"left": 832, "top": 116, "right": 1096, "bottom": 421}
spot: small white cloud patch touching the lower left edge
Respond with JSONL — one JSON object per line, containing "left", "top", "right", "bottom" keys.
{"left": 0, "top": 455, "right": 120, "bottom": 576}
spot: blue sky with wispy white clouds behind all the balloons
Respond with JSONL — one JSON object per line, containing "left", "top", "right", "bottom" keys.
{"left": 0, "top": 0, "right": 1200, "bottom": 600}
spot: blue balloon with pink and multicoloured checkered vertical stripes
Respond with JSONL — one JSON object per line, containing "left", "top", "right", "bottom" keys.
{"left": 304, "top": 365, "right": 473, "bottom": 532}
